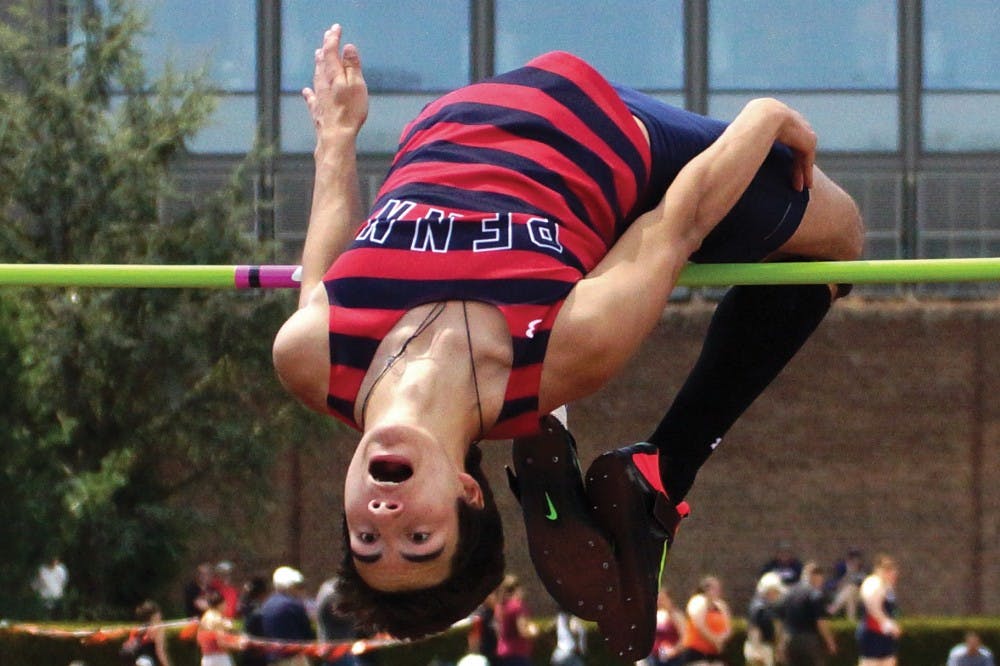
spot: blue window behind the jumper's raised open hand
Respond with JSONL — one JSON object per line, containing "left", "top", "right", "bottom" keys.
{"left": 281, "top": 0, "right": 471, "bottom": 152}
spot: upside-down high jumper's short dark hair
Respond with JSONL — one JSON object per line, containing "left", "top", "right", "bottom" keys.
{"left": 337, "top": 444, "right": 504, "bottom": 638}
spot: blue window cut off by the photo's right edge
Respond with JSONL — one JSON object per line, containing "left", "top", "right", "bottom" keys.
{"left": 923, "top": 0, "right": 1000, "bottom": 152}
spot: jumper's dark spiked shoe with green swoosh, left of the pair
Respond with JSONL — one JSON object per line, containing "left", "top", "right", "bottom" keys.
{"left": 507, "top": 416, "right": 620, "bottom": 620}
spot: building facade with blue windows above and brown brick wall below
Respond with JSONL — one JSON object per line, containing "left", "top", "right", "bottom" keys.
{"left": 0, "top": 0, "right": 1000, "bottom": 614}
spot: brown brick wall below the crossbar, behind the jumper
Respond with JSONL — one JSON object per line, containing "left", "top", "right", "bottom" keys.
{"left": 229, "top": 299, "right": 1000, "bottom": 615}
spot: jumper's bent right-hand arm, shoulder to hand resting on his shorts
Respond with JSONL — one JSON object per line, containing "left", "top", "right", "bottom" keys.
{"left": 540, "top": 99, "right": 816, "bottom": 409}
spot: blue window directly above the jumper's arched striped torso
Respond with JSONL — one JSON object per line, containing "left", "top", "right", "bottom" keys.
{"left": 496, "top": 0, "right": 684, "bottom": 103}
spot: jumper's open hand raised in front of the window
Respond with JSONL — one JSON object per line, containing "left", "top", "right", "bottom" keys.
{"left": 302, "top": 23, "right": 368, "bottom": 142}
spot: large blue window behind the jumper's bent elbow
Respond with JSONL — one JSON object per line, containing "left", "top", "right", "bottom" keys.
{"left": 709, "top": 0, "right": 899, "bottom": 151}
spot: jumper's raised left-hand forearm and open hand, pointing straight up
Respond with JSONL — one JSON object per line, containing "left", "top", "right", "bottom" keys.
{"left": 299, "top": 25, "right": 368, "bottom": 307}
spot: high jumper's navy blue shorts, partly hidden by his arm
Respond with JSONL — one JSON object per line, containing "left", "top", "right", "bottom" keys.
{"left": 615, "top": 86, "right": 809, "bottom": 263}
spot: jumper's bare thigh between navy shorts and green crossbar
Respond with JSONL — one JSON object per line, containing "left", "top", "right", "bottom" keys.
{"left": 775, "top": 167, "right": 864, "bottom": 261}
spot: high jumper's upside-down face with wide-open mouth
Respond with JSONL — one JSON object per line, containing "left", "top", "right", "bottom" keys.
{"left": 344, "top": 426, "right": 483, "bottom": 592}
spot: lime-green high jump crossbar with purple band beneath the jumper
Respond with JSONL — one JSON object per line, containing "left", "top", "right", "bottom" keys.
{"left": 0, "top": 257, "right": 1000, "bottom": 289}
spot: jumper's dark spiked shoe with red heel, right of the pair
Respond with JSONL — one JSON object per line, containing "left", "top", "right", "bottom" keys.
{"left": 587, "top": 442, "right": 689, "bottom": 661}
